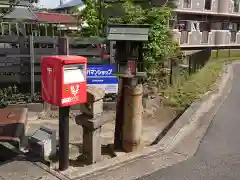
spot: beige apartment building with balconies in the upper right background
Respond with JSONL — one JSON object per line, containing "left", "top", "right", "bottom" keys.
{"left": 172, "top": 0, "right": 240, "bottom": 48}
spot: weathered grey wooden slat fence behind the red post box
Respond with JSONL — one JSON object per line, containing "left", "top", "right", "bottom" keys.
{"left": 0, "top": 36, "right": 103, "bottom": 100}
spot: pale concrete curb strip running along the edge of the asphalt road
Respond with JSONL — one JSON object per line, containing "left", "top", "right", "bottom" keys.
{"left": 48, "top": 64, "right": 233, "bottom": 179}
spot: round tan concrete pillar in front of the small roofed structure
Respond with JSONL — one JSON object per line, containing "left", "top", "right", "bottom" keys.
{"left": 123, "top": 78, "right": 143, "bottom": 152}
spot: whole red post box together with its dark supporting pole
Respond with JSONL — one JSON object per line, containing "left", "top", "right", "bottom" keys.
{"left": 41, "top": 56, "right": 87, "bottom": 171}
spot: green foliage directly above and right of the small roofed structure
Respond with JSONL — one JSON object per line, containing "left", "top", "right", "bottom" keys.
{"left": 108, "top": 0, "right": 180, "bottom": 62}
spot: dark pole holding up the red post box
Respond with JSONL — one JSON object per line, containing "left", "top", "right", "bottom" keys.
{"left": 59, "top": 106, "right": 70, "bottom": 171}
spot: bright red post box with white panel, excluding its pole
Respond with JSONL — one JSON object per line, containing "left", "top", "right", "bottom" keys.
{"left": 41, "top": 56, "right": 87, "bottom": 107}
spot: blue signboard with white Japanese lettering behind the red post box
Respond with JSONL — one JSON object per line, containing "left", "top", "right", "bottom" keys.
{"left": 87, "top": 64, "right": 118, "bottom": 94}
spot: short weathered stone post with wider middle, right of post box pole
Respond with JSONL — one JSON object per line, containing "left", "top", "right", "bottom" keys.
{"left": 76, "top": 87, "right": 106, "bottom": 164}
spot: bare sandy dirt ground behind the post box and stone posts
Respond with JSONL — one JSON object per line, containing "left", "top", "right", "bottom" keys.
{"left": 27, "top": 99, "right": 176, "bottom": 167}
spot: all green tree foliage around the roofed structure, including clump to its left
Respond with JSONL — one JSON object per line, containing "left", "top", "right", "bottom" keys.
{"left": 76, "top": 0, "right": 180, "bottom": 62}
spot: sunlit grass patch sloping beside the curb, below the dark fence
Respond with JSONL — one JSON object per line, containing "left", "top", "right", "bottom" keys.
{"left": 164, "top": 59, "right": 227, "bottom": 109}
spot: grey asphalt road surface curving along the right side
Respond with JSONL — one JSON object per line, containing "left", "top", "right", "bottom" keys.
{"left": 139, "top": 65, "right": 240, "bottom": 180}
